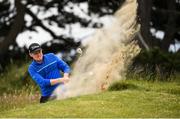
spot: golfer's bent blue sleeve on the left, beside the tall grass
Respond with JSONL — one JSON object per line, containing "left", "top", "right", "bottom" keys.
{"left": 28, "top": 67, "right": 51, "bottom": 87}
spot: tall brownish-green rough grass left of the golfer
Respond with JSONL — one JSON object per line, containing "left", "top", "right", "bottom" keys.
{"left": 0, "top": 63, "right": 40, "bottom": 111}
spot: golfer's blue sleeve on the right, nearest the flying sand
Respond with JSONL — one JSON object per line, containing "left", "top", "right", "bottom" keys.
{"left": 55, "top": 56, "right": 71, "bottom": 73}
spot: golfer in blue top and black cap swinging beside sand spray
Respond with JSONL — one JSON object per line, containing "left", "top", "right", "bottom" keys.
{"left": 28, "top": 43, "right": 70, "bottom": 103}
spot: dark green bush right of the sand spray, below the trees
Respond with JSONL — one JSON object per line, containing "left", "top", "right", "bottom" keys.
{"left": 127, "top": 48, "right": 180, "bottom": 81}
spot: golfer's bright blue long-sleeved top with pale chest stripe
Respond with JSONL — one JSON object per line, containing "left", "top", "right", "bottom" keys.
{"left": 28, "top": 53, "right": 70, "bottom": 96}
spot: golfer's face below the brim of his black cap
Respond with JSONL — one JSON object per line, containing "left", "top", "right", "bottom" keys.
{"left": 29, "top": 50, "right": 43, "bottom": 62}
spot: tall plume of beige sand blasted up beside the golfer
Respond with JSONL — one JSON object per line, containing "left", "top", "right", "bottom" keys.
{"left": 55, "top": 0, "right": 140, "bottom": 99}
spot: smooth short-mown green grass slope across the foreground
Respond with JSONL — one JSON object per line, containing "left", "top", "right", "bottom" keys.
{"left": 0, "top": 80, "right": 180, "bottom": 118}
